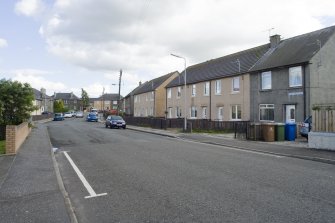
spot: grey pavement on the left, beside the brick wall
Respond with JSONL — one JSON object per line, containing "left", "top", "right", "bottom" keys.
{"left": 0, "top": 124, "right": 70, "bottom": 222}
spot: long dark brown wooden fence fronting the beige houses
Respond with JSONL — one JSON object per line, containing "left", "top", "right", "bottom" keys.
{"left": 124, "top": 116, "right": 249, "bottom": 139}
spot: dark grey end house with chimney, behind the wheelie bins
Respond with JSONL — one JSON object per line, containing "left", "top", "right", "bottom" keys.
{"left": 250, "top": 26, "right": 335, "bottom": 122}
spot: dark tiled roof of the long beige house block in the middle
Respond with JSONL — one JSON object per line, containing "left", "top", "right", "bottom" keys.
{"left": 166, "top": 44, "right": 270, "bottom": 87}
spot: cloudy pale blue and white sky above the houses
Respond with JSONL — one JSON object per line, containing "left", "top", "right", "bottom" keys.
{"left": 0, "top": 0, "right": 335, "bottom": 97}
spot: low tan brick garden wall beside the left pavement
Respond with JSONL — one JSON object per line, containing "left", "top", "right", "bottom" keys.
{"left": 6, "top": 122, "right": 31, "bottom": 154}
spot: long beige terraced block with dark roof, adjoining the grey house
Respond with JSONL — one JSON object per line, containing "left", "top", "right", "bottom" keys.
{"left": 166, "top": 44, "right": 269, "bottom": 121}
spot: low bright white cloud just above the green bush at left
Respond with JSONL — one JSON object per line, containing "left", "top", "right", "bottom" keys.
{"left": 11, "top": 69, "right": 68, "bottom": 95}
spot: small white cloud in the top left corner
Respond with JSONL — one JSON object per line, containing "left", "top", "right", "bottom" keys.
{"left": 14, "top": 0, "right": 45, "bottom": 17}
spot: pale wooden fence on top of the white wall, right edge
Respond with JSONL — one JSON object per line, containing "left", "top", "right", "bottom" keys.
{"left": 312, "top": 108, "right": 335, "bottom": 132}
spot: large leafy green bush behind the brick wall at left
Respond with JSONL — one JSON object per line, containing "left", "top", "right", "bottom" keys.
{"left": 0, "top": 79, "right": 37, "bottom": 125}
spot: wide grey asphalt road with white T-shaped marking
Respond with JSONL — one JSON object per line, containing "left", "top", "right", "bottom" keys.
{"left": 48, "top": 119, "right": 335, "bottom": 222}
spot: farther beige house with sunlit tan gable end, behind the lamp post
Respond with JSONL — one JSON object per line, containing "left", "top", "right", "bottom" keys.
{"left": 133, "top": 71, "right": 179, "bottom": 117}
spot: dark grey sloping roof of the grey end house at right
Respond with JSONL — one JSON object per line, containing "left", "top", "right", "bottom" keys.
{"left": 251, "top": 26, "right": 335, "bottom": 71}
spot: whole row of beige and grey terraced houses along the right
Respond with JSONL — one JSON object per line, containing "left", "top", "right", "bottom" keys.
{"left": 123, "top": 26, "right": 335, "bottom": 122}
